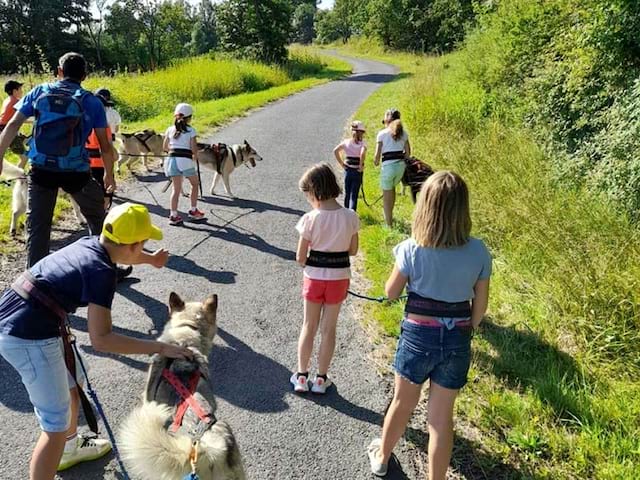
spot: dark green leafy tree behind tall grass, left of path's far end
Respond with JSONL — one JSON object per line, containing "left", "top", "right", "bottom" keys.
{"left": 218, "top": 0, "right": 291, "bottom": 63}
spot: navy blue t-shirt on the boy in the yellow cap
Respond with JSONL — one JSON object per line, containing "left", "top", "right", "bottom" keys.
{"left": 0, "top": 237, "right": 116, "bottom": 340}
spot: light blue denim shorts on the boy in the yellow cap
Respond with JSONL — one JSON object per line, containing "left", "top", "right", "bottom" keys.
{"left": 0, "top": 334, "right": 82, "bottom": 432}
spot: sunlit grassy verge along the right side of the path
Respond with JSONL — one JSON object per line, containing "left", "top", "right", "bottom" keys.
{"left": 332, "top": 42, "right": 640, "bottom": 479}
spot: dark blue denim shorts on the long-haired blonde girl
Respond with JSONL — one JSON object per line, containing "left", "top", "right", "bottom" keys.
{"left": 393, "top": 321, "right": 471, "bottom": 390}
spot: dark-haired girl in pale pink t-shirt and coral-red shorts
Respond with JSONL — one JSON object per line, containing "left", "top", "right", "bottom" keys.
{"left": 290, "top": 163, "right": 360, "bottom": 393}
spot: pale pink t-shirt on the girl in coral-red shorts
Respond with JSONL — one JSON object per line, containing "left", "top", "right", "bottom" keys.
{"left": 296, "top": 207, "right": 360, "bottom": 280}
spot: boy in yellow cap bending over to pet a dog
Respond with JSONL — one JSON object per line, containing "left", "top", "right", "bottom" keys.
{"left": 0, "top": 203, "right": 192, "bottom": 480}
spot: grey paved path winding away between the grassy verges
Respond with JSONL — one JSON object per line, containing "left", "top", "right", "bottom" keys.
{"left": 0, "top": 55, "right": 417, "bottom": 480}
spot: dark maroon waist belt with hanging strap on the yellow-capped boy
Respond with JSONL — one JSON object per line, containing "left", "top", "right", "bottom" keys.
{"left": 11, "top": 270, "right": 98, "bottom": 434}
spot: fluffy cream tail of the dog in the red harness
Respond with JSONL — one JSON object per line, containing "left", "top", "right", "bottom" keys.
{"left": 119, "top": 402, "right": 191, "bottom": 480}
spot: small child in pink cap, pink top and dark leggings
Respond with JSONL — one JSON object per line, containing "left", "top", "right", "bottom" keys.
{"left": 333, "top": 120, "right": 367, "bottom": 211}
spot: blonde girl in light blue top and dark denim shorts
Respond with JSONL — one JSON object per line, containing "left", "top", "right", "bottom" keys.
{"left": 368, "top": 171, "right": 491, "bottom": 480}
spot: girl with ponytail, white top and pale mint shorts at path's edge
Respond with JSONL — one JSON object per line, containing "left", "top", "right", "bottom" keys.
{"left": 373, "top": 108, "right": 411, "bottom": 227}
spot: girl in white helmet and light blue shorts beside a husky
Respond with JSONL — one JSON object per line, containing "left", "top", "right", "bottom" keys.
{"left": 163, "top": 103, "right": 206, "bottom": 225}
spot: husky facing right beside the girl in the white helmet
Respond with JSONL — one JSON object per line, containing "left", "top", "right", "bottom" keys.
{"left": 198, "top": 140, "right": 262, "bottom": 197}
